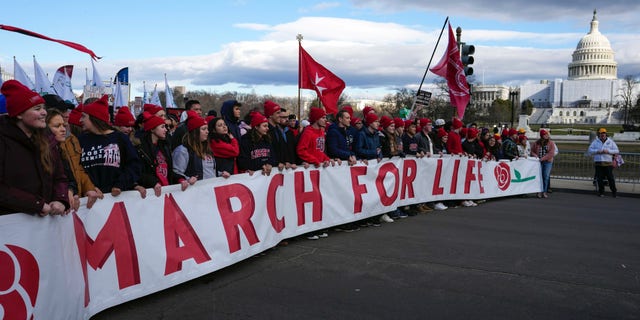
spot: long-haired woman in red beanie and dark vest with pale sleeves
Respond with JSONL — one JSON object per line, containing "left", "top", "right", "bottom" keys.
{"left": 172, "top": 111, "right": 230, "bottom": 191}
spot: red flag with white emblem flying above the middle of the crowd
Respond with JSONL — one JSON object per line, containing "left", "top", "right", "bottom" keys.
{"left": 298, "top": 43, "right": 345, "bottom": 115}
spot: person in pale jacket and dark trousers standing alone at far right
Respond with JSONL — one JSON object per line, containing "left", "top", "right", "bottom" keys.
{"left": 587, "top": 128, "right": 620, "bottom": 198}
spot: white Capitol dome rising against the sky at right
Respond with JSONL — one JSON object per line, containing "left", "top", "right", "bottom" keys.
{"left": 569, "top": 10, "right": 618, "bottom": 80}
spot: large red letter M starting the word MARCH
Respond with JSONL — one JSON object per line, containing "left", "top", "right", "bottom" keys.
{"left": 73, "top": 202, "right": 140, "bottom": 307}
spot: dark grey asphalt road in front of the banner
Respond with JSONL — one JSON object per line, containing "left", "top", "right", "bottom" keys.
{"left": 93, "top": 191, "right": 640, "bottom": 320}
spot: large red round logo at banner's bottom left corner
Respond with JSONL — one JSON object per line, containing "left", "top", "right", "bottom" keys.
{"left": 0, "top": 244, "right": 40, "bottom": 319}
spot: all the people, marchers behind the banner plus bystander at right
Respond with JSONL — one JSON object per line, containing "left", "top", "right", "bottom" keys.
{"left": 0, "top": 77, "right": 596, "bottom": 239}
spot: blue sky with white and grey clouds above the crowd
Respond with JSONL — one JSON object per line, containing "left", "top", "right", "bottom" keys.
{"left": 0, "top": 0, "right": 640, "bottom": 98}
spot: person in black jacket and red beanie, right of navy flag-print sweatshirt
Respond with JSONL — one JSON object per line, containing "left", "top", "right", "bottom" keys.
{"left": 136, "top": 112, "right": 175, "bottom": 197}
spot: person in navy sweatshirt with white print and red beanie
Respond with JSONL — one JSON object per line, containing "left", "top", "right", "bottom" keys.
{"left": 78, "top": 94, "right": 147, "bottom": 198}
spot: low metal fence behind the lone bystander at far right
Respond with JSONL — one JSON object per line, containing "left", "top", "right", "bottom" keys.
{"left": 551, "top": 150, "right": 640, "bottom": 183}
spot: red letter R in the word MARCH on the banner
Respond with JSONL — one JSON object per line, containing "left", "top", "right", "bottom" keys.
{"left": 213, "top": 183, "right": 260, "bottom": 253}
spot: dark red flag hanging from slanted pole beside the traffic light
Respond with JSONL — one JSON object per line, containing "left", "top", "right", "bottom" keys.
{"left": 429, "top": 24, "right": 470, "bottom": 119}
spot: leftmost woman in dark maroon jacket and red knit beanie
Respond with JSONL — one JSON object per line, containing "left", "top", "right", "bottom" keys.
{"left": 0, "top": 80, "right": 70, "bottom": 216}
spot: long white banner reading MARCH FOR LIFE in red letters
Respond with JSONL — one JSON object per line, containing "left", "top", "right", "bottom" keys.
{"left": 0, "top": 157, "right": 542, "bottom": 319}
